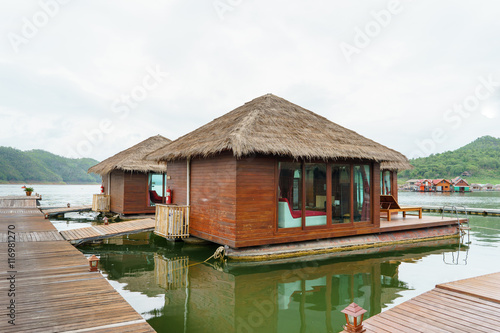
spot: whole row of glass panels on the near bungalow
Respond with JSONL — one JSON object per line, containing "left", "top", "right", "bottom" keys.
{"left": 278, "top": 162, "right": 372, "bottom": 228}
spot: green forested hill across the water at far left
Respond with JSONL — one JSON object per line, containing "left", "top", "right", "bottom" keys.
{"left": 0, "top": 146, "right": 101, "bottom": 184}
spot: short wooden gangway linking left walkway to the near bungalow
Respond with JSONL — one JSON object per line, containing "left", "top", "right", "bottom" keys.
{"left": 61, "top": 219, "right": 155, "bottom": 244}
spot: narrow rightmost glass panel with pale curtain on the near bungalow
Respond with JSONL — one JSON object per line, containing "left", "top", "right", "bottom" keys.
{"left": 353, "top": 165, "right": 371, "bottom": 222}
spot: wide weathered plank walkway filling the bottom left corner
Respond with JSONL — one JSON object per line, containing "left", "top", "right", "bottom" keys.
{"left": 0, "top": 202, "right": 154, "bottom": 332}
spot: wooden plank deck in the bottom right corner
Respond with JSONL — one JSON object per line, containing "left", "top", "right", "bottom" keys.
{"left": 363, "top": 273, "right": 500, "bottom": 333}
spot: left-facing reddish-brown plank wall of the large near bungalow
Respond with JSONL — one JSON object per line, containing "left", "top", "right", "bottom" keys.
{"left": 190, "top": 154, "right": 236, "bottom": 246}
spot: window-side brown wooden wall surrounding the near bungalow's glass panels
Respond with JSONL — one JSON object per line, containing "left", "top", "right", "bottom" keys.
{"left": 228, "top": 156, "right": 380, "bottom": 247}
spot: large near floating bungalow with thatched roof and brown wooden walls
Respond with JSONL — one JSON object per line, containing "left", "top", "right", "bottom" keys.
{"left": 147, "top": 94, "right": 464, "bottom": 255}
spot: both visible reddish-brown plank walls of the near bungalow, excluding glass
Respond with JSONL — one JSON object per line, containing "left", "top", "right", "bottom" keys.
{"left": 178, "top": 153, "right": 380, "bottom": 248}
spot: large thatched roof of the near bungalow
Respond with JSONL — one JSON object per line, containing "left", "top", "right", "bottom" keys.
{"left": 147, "top": 94, "right": 408, "bottom": 167}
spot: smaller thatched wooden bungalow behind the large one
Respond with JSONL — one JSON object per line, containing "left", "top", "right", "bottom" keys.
{"left": 88, "top": 135, "right": 170, "bottom": 214}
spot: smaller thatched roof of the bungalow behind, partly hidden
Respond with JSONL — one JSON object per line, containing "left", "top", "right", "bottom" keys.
{"left": 88, "top": 135, "right": 171, "bottom": 175}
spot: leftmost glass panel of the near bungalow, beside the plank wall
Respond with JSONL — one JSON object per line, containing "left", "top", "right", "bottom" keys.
{"left": 278, "top": 162, "right": 302, "bottom": 228}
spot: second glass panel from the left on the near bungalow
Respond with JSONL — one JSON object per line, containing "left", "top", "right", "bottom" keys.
{"left": 305, "top": 163, "right": 326, "bottom": 227}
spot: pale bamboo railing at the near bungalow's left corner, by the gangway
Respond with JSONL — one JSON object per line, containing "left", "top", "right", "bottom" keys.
{"left": 155, "top": 204, "right": 189, "bottom": 238}
